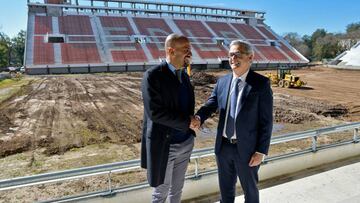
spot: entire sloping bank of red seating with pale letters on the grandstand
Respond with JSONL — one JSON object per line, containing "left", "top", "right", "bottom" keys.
{"left": 27, "top": 12, "right": 306, "bottom": 70}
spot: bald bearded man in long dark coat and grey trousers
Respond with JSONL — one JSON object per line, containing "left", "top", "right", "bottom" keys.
{"left": 141, "top": 34, "right": 195, "bottom": 203}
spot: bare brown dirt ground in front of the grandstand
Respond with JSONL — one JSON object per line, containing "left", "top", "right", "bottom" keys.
{"left": 0, "top": 67, "right": 360, "bottom": 202}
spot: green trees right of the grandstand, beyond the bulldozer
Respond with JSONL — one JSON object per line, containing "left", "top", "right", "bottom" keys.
{"left": 283, "top": 22, "right": 360, "bottom": 61}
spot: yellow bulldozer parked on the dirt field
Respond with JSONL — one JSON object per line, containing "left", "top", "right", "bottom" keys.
{"left": 265, "top": 67, "right": 306, "bottom": 88}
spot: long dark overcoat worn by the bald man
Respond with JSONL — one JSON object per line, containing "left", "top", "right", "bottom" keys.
{"left": 141, "top": 62, "right": 195, "bottom": 187}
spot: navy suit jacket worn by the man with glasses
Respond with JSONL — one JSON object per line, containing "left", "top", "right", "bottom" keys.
{"left": 196, "top": 70, "right": 273, "bottom": 162}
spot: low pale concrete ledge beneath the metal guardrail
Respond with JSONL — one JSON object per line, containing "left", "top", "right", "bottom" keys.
{"left": 79, "top": 143, "right": 360, "bottom": 203}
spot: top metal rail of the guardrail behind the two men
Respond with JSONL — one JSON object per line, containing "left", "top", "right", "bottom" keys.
{"left": 0, "top": 122, "right": 360, "bottom": 191}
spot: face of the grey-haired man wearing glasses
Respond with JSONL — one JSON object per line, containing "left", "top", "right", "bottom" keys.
{"left": 229, "top": 45, "right": 254, "bottom": 71}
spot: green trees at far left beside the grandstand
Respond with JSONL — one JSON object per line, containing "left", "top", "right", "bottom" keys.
{"left": 0, "top": 30, "right": 26, "bottom": 68}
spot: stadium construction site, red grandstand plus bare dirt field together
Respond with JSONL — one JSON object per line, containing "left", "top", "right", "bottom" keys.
{"left": 0, "top": 1, "right": 360, "bottom": 202}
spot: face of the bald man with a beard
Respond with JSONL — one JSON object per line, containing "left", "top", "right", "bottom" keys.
{"left": 172, "top": 41, "right": 192, "bottom": 67}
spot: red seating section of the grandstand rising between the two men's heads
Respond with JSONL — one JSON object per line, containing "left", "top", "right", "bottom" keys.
{"left": 174, "top": 20, "right": 227, "bottom": 59}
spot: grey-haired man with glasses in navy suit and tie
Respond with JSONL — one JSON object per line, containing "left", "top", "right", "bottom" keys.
{"left": 191, "top": 40, "right": 273, "bottom": 203}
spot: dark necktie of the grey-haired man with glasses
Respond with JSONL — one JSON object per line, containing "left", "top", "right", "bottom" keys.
{"left": 225, "top": 78, "right": 241, "bottom": 139}
